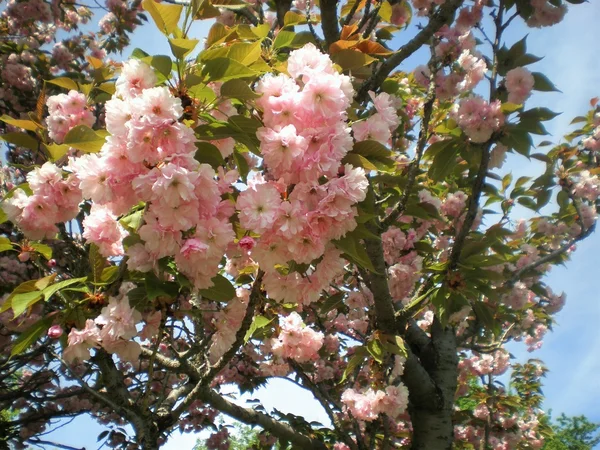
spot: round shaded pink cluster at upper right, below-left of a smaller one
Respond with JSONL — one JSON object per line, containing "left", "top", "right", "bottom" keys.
{"left": 450, "top": 96, "right": 504, "bottom": 143}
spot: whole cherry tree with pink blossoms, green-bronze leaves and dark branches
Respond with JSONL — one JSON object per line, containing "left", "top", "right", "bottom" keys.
{"left": 0, "top": 0, "right": 600, "bottom": 450}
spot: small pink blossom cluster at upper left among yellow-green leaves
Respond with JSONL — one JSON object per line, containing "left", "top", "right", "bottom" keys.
{"left": 46, "top": 91, "right": 94, "bottom": 144}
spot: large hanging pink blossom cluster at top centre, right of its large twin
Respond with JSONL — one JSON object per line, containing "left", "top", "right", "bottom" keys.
{"left": 236, "top": 44, "right": 368, "bottom": 304}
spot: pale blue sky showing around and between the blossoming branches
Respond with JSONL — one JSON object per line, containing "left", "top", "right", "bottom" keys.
{"left": 41, "top": 1, "right": 600, "bottom": 450}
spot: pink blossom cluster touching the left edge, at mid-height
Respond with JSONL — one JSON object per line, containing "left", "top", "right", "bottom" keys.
{"left": 2, "top": 162, "right": 81, "bottom": 240}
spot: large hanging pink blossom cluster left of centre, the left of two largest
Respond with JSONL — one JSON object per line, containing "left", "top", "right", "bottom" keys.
{"left": 70, "top": 60, "right": 234, "bottom": 289}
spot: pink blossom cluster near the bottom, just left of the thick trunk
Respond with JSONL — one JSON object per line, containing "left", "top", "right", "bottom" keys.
{"left": 342, "top": 383, "right": 408, "bottom": 422}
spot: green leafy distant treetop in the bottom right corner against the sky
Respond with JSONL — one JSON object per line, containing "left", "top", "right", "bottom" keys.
{"left": 543, "top": 414, "right": 600, "bottom": 450}
